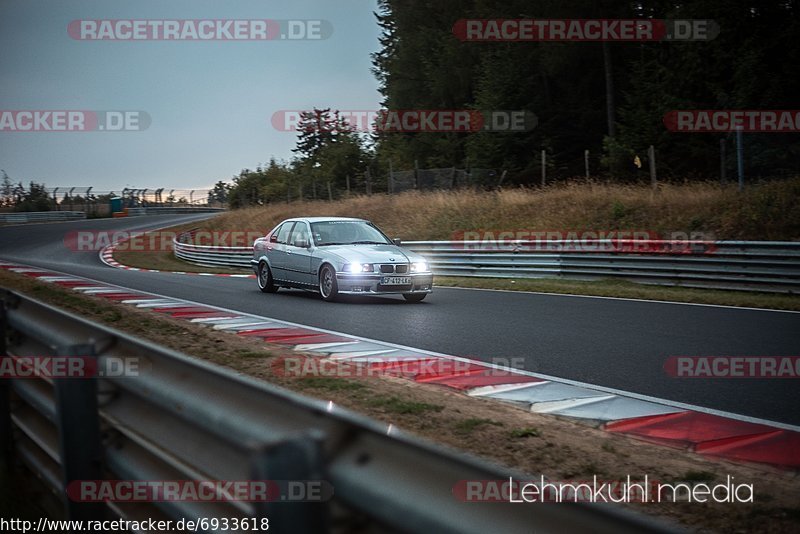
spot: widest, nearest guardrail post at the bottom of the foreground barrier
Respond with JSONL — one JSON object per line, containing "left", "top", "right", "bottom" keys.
{"left": 252, "top": 431, "right": 330, "bottom": 533}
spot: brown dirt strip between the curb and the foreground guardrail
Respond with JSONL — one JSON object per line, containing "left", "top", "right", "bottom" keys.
{"left": 0, "top": 270, "right": 800, "bottom": 532}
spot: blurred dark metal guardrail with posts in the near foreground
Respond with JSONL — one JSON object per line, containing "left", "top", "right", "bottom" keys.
{"left": 0, "top": 292, "right": 667, "bottom": 534}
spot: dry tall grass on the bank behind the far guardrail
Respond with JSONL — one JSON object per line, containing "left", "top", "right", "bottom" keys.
{"left": 195, "top": 178, "right": 800, "bottom": 240}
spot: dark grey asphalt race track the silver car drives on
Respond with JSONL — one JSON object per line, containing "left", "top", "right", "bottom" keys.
{"left": 0, "top": 214, "right": 800, "bottom": 425}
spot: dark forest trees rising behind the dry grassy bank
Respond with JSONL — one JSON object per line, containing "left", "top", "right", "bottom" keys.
{"left": 218, "top": 0, "right": 800, "bottom": 207}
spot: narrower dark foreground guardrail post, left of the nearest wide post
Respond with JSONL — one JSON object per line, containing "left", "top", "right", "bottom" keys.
{"left": 53, "top": 345, "right": 104, "bottom": 520}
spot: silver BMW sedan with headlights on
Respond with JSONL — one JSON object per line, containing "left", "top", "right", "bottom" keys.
{"left": 250, "top": 217, "right": 433, "bottom": 302}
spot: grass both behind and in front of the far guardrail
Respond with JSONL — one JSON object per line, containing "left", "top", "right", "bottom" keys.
{"left": 115, "top": 178, "right": 800, "bottom": 309}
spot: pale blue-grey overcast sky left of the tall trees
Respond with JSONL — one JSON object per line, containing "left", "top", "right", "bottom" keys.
{"left": 0, "top": 0, "right": 380, "bottom": 191}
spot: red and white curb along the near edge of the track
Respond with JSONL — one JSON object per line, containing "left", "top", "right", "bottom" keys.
{"left": 0, "top": 261, "right": 800, "bottom": 470}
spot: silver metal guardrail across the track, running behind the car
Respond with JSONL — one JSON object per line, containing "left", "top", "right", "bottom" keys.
{"left": 173, "top": 236, "right": 800, "bottom": 293}
